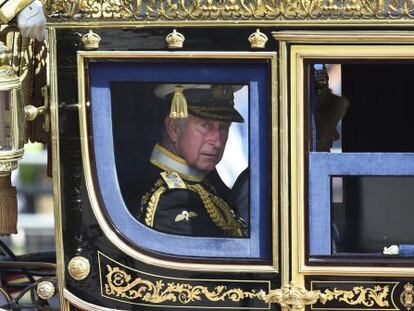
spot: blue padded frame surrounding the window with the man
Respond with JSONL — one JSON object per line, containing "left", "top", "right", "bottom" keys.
{"left": 89, "top": 60, "right": 272, "bottom": 259}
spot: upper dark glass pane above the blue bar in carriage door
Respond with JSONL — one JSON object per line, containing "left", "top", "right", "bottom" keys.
{"left": 308, "top": 62, "right": 414, "bottom": 152}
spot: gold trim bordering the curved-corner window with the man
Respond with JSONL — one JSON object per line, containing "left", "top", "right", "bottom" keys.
{"left": 77, "top": 51, "right": 279, "bottom": 273}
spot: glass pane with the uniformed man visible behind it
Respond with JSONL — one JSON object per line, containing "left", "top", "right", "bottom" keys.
{"left": 111, "top": 82, "right": 250, "bottom": 238}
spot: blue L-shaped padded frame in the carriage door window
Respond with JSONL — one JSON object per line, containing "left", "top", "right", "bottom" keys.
{"left": 309, "top": 152, "right": 414, "bottom": 255}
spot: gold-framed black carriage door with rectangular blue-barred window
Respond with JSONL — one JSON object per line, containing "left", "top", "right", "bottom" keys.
{"left": 274, "top": 31, "right": 414, "bottom": 310}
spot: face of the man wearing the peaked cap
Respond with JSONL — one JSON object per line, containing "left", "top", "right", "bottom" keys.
{"left": 176, "top": 115, "right": 230, "bottom": 172}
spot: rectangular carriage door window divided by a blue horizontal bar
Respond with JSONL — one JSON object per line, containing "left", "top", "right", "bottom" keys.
{"left": 305, "top": 60, "right": 414, "bottom": 258}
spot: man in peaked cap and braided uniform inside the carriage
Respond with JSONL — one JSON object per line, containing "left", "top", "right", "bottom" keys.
{"left": 139, "top": 85, "right": 247, "bottom": 237}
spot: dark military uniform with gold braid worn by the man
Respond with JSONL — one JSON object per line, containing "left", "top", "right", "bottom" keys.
{"left": 139, "top": 145, "right": 247, "bottom": 237}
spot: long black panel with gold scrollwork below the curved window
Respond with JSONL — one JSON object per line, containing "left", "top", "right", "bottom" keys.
{"left": 98, "top": 252, "right": 270, "bottom": 310}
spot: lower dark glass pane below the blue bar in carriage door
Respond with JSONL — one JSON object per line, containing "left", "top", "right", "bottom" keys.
{"left": 331, "top": 176, "right": 414, "bottom": 255}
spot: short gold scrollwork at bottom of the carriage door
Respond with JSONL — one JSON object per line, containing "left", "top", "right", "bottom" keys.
{"left": 324, "top": 285, "right": 390, "bottom": 307}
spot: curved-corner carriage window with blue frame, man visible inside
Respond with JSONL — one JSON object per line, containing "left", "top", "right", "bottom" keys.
{"left": 82, "top": 53, "right": 277, "bottom": 263}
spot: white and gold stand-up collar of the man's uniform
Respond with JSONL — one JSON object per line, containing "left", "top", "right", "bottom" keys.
{"left": 150, "top": 144, "right": 207, "bottom": 181}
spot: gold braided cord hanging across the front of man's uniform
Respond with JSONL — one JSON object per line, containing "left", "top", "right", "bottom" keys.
{"left": 188, "top": 184, "right": 245, "bottom": 237}
